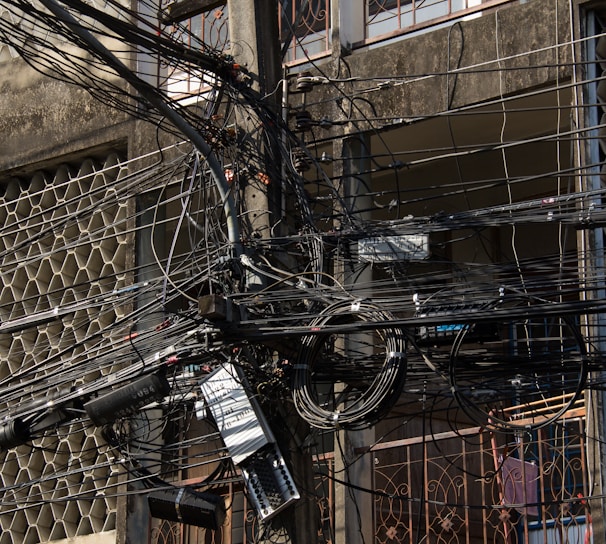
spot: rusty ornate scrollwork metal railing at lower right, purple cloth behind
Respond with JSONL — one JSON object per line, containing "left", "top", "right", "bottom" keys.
{"left": 373, "top": 417, "right": 591, "bottom": 544}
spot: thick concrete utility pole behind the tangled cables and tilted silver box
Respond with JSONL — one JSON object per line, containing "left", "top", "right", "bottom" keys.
{"left": 227, "top": 0, "right": 319, "bottom": 544}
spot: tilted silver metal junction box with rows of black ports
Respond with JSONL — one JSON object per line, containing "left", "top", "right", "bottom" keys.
{"left": 196, "top": 365, "right": 299, "bottom": 519}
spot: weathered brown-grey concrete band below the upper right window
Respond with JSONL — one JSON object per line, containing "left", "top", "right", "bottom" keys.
{"left": 310, "top": 0, "right": 572, "bottom": 132}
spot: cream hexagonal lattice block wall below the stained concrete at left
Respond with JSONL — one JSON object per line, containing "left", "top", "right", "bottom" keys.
{"left": 0, "top": 154, "right": 130, "bottom": 544}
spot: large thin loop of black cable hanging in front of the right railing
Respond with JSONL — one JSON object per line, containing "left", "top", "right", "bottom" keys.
{"left": 449, "top": 297, "right": 588, "bottom": 432}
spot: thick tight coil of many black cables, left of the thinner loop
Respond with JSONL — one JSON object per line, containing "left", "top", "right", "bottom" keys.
{"left": 292, "top": 302, "right": 406, "bottom": 429}
